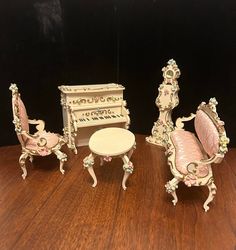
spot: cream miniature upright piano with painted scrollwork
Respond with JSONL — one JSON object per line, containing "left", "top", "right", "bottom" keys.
{"left": 58, "top": 83, "right": 130, "bottom": 153}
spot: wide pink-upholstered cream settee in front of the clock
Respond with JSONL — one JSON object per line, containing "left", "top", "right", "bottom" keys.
{"left": 165, "top": 98, "right": 229, "bottom": 212}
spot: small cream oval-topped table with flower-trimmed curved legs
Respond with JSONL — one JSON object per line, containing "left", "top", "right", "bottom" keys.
{"left": 83, "top": 128, "right": 136, "bottom": 190}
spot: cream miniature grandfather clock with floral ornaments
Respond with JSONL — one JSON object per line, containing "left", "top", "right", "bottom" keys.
{"left": 146, "top": 59, "right": 180, "bottom": 148}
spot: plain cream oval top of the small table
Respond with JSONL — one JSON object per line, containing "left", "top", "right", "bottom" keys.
{"left": 89, "top": 128, "right": 135, "bottom": 156}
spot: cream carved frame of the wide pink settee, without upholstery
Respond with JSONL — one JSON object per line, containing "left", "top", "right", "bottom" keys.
{"left": 165, "top": 98, "right": 229, "bottom": 212}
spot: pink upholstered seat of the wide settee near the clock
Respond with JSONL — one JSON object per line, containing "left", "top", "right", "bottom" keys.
{"left": 171, "top": 130, "right": 209, "bottom": 177}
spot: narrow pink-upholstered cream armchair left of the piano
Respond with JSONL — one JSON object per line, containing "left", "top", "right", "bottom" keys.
{"left": 9, "top": 84, "right": 67, "bottom": 179}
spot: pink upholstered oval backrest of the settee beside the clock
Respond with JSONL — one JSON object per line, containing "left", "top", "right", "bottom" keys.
{"left": 194, "top": 110, "right": 220, "bottom": 156}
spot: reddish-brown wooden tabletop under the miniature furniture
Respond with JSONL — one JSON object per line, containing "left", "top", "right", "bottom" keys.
{"left": 0, "top": 135, "right": 236, "bottom": 250}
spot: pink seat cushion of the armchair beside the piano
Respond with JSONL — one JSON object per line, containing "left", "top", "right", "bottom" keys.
{"left": 26, "top": 131, "right": 59, "bottom": 155}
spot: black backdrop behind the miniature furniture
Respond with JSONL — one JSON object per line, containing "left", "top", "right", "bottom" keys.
{"left": 0, "top": 0, "right": 236, "bottom": 147}
